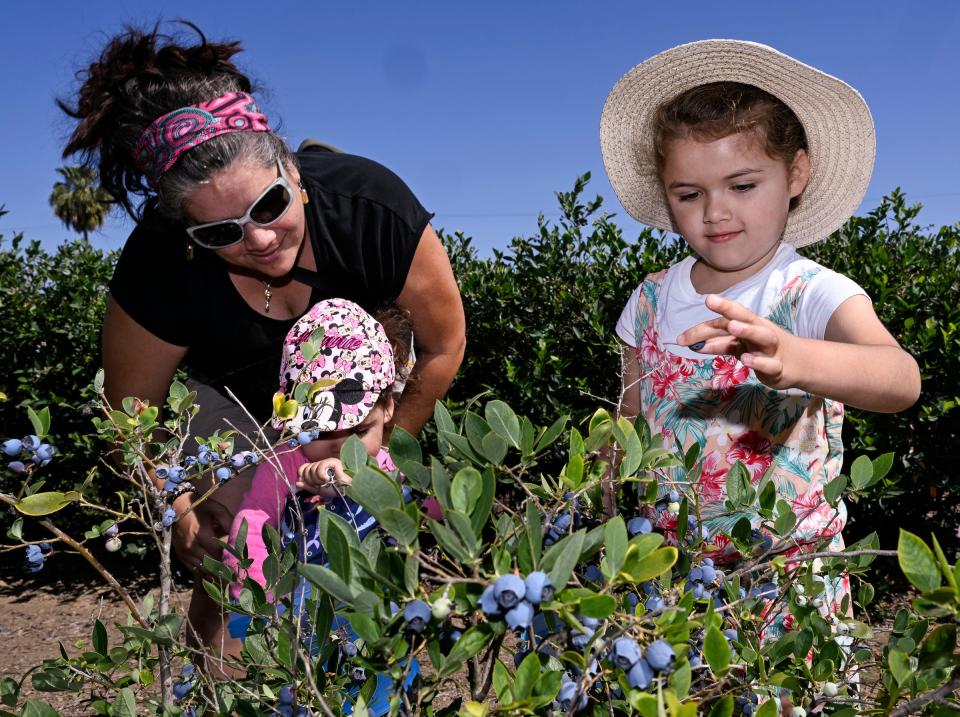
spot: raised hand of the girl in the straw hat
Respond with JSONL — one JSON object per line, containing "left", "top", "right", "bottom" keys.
{"left": 677, "top": 294, "right": 796, "bottom": 389}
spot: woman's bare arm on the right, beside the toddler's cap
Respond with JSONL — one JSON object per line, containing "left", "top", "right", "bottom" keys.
{"left": 394, "top": 224, "right": 466, "bottom": 434}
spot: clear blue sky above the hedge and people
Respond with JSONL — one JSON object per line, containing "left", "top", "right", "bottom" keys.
{"left": 0, "top": 0, "right": 960, "bottom": 253}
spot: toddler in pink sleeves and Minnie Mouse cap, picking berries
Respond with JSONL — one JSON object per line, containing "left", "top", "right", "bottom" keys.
{"left": 223, "top": 299, "right": 420, "bottom": 714}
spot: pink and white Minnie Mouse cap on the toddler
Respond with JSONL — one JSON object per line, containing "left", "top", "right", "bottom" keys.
{"left": 272, "top": 299, "right": 395, "bottom": 433}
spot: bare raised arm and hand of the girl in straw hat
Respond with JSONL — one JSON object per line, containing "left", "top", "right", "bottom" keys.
{"left": 677, "top": 295, "right": 920, "bottom": 413}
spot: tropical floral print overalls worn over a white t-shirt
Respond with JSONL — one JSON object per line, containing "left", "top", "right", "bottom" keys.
{"left": 634, "top": 267, "right": 849, "bottom": 624}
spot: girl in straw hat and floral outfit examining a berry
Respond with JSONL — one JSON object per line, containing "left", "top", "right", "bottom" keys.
{"left": 600, "top": 40, "right": 920, "bottom": 611}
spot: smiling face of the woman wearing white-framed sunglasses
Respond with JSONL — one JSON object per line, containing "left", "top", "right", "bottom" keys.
{"left": 184, "top": 164, "right": 306, "bottom": 278}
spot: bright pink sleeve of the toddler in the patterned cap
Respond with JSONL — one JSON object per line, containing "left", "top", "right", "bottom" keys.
{"left": 223, "top": 449, "right": 305, "bottom": 599}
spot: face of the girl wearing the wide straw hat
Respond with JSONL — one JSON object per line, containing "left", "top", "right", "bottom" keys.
{"left": 661, "top": 134, "right": 810, "bottom": 293}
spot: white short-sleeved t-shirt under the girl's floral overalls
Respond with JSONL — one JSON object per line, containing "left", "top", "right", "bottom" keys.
{"left": 617, "top": 243, "right": 867, "bottom": 359}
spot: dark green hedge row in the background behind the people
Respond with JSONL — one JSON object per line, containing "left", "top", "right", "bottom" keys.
{"left": 0, "top": 183, "right": 960, "bottom": 545}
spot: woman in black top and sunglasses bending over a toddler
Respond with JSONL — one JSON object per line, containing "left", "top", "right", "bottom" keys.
{"left": 59, "top": 25, "right": 464, "bottom": 644}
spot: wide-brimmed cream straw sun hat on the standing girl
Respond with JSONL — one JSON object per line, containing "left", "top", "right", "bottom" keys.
{"left": 600, "top": 40, "right": 876, "bottom": 246}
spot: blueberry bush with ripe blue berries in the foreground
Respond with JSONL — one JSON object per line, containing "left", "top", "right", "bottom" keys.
{"left": 0, "top": 376, "right": 960, "bottom": 717}
